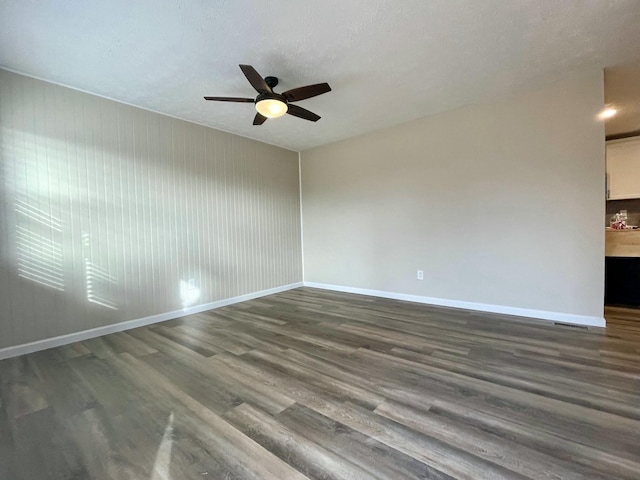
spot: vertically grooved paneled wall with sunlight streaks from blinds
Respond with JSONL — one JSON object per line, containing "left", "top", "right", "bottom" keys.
{"left": 0, "top": 70, "right": 302, "bottom": 348}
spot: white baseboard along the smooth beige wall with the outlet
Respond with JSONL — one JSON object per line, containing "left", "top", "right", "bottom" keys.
{"left": 304, "top": 282, "right": 606, "bottom": 327}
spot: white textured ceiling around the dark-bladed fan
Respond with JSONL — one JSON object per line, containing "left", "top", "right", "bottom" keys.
{"left": 0, "top": 0, "right": 640, "bottom": 150}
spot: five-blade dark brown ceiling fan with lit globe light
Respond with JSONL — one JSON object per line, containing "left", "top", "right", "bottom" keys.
{"left": 204, "top": 65, "right": 331, "bottom": 125}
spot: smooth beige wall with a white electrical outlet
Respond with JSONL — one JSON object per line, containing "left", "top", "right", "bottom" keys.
{"left": 301, "top": 71, "right": 605, "bottom": 318}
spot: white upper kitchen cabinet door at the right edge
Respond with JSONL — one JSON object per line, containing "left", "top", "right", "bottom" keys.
{"left": 607, "top": 137, "right": 640, "bottom": 200}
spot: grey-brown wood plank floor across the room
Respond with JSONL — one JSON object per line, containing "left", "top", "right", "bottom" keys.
{"left": 0, "top": 288, "right": 640, "bottom": 480}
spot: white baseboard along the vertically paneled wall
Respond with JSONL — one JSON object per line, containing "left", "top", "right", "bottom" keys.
{"left": 0, "top": 282, "right": 303, "bottom": 360}
